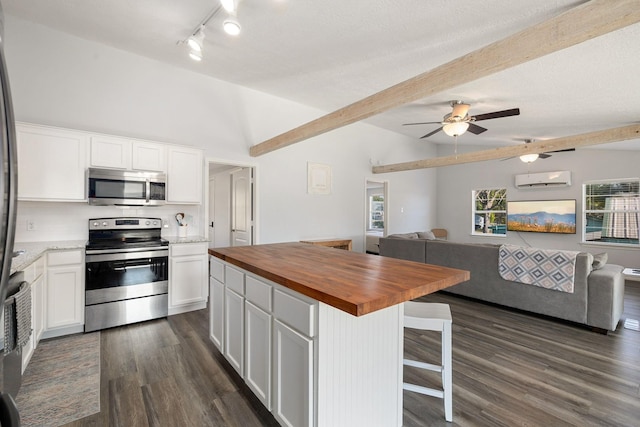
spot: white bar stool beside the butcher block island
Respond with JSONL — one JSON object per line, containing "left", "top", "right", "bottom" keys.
{"left": 402, "top": 301, "right": 453, "bottom": 422}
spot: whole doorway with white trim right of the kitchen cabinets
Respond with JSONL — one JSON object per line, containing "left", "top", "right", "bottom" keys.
{"left": 205, "top": 159, "right": 257, "bottom": 248}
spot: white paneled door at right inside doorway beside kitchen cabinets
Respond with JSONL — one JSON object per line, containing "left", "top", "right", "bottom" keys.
{"left": 231, "top": 168, "right": 253, "bottom": 246}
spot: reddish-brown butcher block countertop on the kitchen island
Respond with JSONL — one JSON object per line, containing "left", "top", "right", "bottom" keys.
{"left": 209, "top": 243, "right": 470, "bottom": 316}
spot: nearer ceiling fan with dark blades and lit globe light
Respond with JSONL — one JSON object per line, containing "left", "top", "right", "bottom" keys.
{"left": 403, "top": 101, "right": 520, "bottom": 139}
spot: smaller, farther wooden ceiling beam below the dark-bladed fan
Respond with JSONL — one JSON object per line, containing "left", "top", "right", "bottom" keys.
{"left": 372, "top": 124, "right": 640, "bottom": 174}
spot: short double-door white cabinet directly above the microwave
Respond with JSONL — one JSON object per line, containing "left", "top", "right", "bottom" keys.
{"left": 91, "top": 135, "right": 167, "bottom": 172}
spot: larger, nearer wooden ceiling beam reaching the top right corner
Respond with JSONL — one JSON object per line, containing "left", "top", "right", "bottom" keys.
{"left": 249, "top": 0, "right": 640, "bottom": 157}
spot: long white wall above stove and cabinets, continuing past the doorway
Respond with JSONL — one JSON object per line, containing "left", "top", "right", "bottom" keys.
{"left": 5, "top": 16, "right": 436, "bottom": 251}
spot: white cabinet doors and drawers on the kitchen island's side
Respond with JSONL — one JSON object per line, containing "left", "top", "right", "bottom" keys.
{"left": 209, "top": 257, "right": 317, "bottom": 426}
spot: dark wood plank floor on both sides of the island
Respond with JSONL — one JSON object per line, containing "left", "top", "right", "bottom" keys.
{"left": 68, "top": 282, "right": 640, "bottom": 427}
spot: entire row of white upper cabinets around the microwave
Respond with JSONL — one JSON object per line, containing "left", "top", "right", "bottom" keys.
{"left": 16, "top": 123, "right": 204, "bottom": 204}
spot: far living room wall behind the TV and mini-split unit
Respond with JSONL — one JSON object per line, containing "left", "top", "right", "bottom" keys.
{"left": 437, "top": 145, "right": 640, "bottom": 267}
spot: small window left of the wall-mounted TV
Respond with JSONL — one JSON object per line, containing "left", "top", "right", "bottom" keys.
{"left": 472, "top": 188, "right": 507, "bottom": 236}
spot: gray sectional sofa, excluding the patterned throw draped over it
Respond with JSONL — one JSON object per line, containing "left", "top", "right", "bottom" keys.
{"left": 380, "top": 233, "right": 624, "bottom": 332}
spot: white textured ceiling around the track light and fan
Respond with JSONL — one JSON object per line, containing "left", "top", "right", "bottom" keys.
{"left": 1, "top": 0, "right": 640, "bottom": 149}
